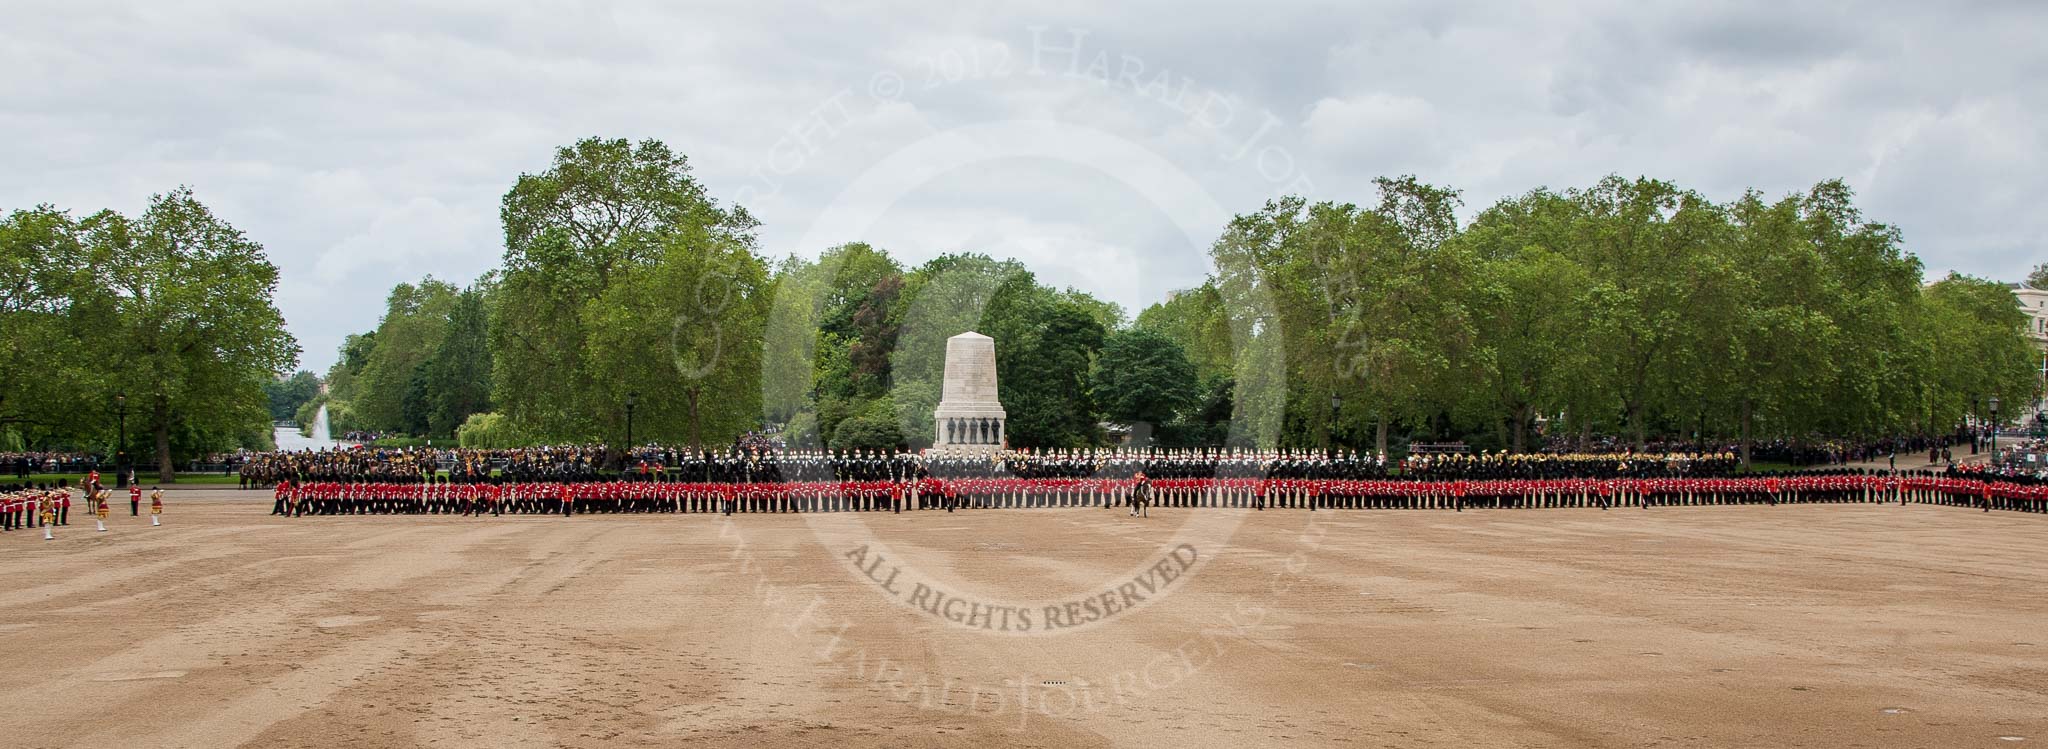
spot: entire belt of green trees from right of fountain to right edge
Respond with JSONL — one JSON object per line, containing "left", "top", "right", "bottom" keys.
{"left": 309, "top": 139, "right": 2038, "bottom": 458}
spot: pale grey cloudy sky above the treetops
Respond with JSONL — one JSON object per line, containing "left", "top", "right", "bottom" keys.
{"left": 0, "top": 0, "right": 2048, "bottom": 370}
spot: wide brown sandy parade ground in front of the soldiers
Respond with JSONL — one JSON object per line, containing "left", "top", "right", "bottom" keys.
{"left": 0, "top": 489, "right": 2048, "bottom": 747}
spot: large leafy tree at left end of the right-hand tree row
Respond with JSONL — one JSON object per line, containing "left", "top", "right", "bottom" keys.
{"left": 1210, "top": 178, "right": 1470, "bottom": 448}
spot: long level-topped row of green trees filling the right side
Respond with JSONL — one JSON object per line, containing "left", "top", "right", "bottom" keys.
{"left": 1196, "top": 178, "right": 2040, "bottom": 458}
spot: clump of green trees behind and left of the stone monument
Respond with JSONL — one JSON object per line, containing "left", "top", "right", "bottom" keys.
{"left": 317, "top": 139, "right": 1194, "bottom": 448}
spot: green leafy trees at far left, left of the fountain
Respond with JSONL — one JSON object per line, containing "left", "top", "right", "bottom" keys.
{"left": 0, "top": 188, "right": 299, "bottom": 481}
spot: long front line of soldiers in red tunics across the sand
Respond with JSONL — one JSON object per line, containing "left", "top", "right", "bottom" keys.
{"left": 256, "top": 462, "right": 2048, "bottom": 516}
